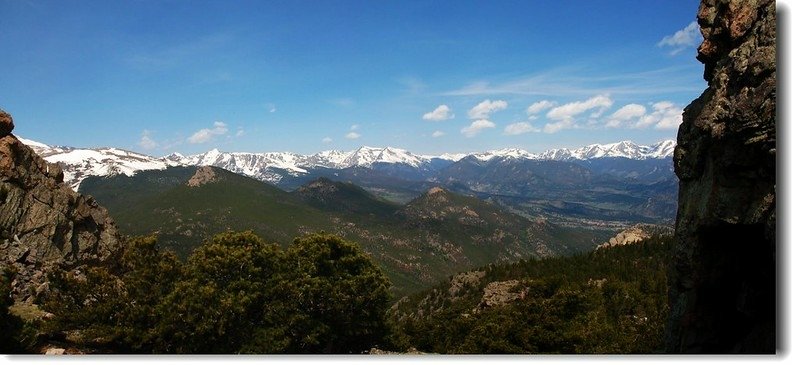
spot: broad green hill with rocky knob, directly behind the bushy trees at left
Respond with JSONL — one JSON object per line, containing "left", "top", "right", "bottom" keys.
{"left": 82, "top": 167, "right": 331, "bottom": 257}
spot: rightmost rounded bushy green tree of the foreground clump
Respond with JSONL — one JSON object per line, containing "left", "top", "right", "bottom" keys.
{"left": 282, "top": 234, "right": 390, "bottom": 353}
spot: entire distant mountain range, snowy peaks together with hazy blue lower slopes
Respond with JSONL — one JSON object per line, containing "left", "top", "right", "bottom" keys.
{"left": 21, "top": 136, "right": 677, "bottom": 227}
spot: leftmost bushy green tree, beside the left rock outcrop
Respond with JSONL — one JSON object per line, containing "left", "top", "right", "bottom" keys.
{"left": 44, "top": 237, "right": 181, "bottom": 352}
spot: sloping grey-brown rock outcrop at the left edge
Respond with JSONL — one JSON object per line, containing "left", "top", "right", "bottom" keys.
{"left": 0, "top": 111, "right": 121, "bottom": 302}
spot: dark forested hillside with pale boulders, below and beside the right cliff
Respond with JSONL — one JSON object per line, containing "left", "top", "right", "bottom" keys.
{"left": 390, "top": 236, "right": 673, "bottom": 354}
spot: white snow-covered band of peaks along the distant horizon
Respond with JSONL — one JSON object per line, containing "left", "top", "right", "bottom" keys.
{"left": 20, "top": 138, "right": 676, "bottom": 190}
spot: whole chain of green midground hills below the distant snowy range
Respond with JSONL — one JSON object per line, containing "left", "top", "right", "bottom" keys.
{"left": 81, "top": 167, "right": 610, "bottom": 293}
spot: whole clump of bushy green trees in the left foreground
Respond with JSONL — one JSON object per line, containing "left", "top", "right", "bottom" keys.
{"left": 43, "top": 232, "right": 389, "bottom": 354}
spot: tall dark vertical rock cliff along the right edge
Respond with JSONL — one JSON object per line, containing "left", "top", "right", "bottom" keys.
{"left": 666, "top": 0, "right": 777, "bottom": 353}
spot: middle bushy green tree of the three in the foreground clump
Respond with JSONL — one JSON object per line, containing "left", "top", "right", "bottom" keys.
{"left": 158, "top": 232, "right": 284, "bottom": 353}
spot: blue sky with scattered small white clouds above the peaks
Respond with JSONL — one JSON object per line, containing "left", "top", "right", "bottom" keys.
{"left": 0, "top": 0, "right": 705, "bottom": 155}
